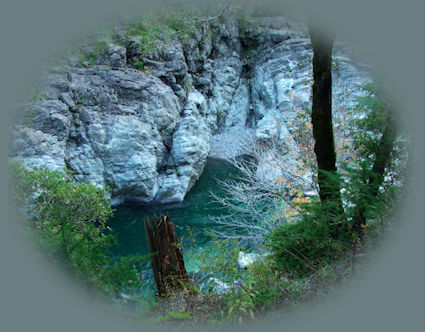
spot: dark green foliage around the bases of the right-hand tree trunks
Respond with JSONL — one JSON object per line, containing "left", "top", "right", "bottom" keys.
{"left": 268, "top": 82, "right": 406, "bottom": 275}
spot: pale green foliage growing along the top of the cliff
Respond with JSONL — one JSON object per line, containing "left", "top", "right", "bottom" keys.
{"left": 74, "top": 4, "right": 243, "bottom": 69}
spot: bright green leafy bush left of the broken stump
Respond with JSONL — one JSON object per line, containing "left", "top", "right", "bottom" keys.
{"left": 10, "top": 163, "right": 143, "bottom": 296}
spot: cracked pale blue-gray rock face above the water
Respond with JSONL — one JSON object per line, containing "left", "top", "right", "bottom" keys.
{"left": 9, "top": 15, "right": 369, "bottom": 204}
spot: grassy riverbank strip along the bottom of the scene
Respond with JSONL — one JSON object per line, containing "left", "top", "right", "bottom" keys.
{"left": 125, "top": 240, "right": 375, "bottom": 331}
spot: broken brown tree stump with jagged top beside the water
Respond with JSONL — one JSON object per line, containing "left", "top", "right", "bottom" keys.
{"left": 145, "top": 215, "right": 189, "bottom": 297}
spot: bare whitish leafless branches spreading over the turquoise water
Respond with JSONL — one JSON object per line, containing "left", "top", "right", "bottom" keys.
{"left": 210, "top": 139, "right": 313, "bottom": 246}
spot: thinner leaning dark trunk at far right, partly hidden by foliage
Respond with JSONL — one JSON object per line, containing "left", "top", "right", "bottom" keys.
{"left": 355, "top": 110, "right": 397, "bottom": 239}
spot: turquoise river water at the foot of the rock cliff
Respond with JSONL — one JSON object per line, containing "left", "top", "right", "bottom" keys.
{"left": 109, "top": 159, "right": 240, "bottom": 291}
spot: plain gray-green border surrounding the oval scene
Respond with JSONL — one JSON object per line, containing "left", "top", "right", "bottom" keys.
{"left": 0, "top": 0, "right": 425, "bottom": 332}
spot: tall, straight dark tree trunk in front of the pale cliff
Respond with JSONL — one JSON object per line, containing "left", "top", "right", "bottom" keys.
{"left": 309, "top": 26, "right": 342, "bottom": 211}
